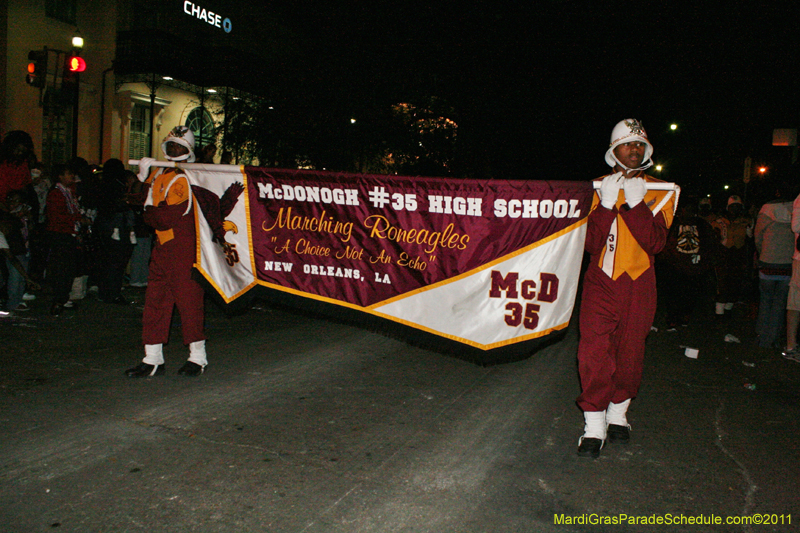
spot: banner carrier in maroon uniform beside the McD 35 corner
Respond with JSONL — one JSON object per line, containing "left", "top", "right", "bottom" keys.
{"left": 577, "top": 119, "right": 677, "bottom": 458}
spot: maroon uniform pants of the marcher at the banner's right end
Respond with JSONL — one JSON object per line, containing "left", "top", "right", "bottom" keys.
{"left": 577, "top": 265, "right": 656, "bottom": 411}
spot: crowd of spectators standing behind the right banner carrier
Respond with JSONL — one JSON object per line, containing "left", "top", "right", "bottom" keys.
{"left": 656, "top": 179, "right": 800, "bottom": 362}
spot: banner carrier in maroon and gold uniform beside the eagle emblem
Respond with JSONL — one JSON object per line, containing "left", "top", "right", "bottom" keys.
{"left": 125, "top": 126, "right": 208, "bottom": 378}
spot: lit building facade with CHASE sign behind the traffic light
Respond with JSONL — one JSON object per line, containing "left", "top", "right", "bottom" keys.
{"left": 0, "top": 0, "right": 280, "bottom": 165}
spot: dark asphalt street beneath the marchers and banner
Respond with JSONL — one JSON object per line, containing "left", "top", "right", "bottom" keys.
{"left": 0, "top": 289, "right": 800, "bottom": 533}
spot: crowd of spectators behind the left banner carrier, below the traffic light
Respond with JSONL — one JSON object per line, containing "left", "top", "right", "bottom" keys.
{"left": 0, "top": 131, "right": 151, "bottom": 316}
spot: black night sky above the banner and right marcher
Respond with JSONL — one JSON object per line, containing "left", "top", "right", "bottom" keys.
{"left": 266, "top": 0, "right": 800, "bottom": 200}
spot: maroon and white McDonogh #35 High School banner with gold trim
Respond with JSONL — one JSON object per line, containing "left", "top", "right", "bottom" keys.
{"left": 148, "top": 165, "right": 593, "bottom": 350}
